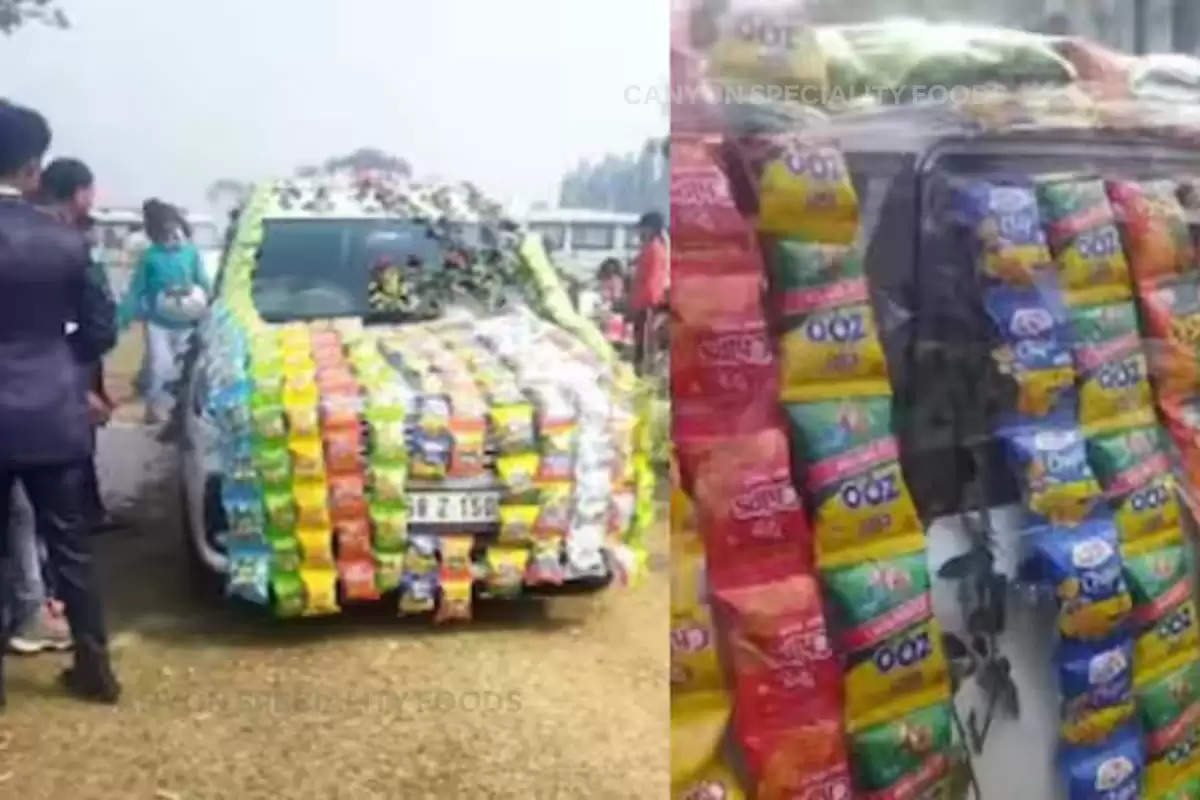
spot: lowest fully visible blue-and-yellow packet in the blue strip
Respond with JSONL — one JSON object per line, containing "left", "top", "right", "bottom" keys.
{"left": 1056, "top": 633, "right": 1134, "bottom": 745}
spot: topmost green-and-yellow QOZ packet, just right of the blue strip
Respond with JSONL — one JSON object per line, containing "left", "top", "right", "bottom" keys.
{"left": 1037, "top": 175, "right": 1132, "bottom": 306}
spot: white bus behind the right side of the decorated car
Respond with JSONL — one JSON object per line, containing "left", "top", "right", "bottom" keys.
{"left": 526, "top": 209, "right": 641, "bottom": 281}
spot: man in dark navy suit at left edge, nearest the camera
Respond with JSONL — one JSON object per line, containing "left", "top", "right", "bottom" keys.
{"left": 0, "top": 102, "right": 120, "bottom": 703}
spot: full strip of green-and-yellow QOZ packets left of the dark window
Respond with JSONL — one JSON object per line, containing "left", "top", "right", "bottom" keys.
{"left": 738, "top": 137, "right": 953, "bottom": 798}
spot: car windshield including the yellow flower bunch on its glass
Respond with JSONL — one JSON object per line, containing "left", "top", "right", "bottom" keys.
{"left": 253, "top": 218, "right": 504, "bottom": 321}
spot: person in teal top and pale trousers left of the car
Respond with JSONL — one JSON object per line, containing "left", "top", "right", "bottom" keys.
{"left": 116, "top": 200, "right": 211, "bottom": 425}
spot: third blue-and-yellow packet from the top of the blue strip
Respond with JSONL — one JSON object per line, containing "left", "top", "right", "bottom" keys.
{"left": 1000, "top": 423, "right": 1100, "bottom": 525}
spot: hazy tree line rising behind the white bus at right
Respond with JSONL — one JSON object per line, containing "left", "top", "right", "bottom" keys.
{"left": 558, "top": 139, "right": 670, "bottom": 215}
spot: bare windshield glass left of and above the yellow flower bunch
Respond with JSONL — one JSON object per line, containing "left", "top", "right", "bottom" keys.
{"left": 253, "top": 219, "right": 445, "bottom": 321}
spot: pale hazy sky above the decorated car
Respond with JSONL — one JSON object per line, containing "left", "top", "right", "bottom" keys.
{"left": 0, "top": 0, "right": 668, "bottom": 207}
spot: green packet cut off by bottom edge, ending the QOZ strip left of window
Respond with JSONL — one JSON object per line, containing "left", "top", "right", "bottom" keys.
{"left": 850, "top": 702, "right": 952, "bottom": 800}
